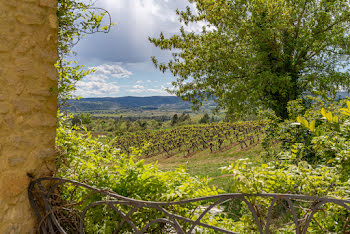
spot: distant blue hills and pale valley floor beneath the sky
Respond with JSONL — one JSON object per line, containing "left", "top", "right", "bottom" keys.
{"left": 61, "top": 96, "right": 224, "bottom": 122}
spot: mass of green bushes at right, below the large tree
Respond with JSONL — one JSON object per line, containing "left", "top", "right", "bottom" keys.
{"left": 223, "top": 99, "right": 350, "bottom": 233}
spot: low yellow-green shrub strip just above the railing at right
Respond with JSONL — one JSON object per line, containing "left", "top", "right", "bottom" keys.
{"left": 223, "top": 159, "right": 350, "bottom": 198}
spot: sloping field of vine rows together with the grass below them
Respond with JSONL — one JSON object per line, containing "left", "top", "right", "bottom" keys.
{"left": 108, "top": 121, "right": 265, "bottom": 191}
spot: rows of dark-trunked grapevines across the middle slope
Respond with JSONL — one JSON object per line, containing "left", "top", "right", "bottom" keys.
{"left": 114, "top": 121, "right": 265, "bottom": 157}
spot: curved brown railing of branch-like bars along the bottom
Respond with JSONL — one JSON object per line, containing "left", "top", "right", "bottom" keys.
{"left": 28, "top": 177, "right": 350, "bottom": 234}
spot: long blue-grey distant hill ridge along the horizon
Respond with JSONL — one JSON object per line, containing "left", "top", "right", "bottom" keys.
{"left": 64, "top": 96, "right": 215, "bottom": 112}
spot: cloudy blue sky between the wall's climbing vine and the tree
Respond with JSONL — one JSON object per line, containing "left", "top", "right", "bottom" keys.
{"left": 73, "top": 0, "right": 201, "bottom": 97}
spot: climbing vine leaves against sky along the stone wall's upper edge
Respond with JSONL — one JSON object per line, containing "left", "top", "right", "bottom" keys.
{"left": 56, "top": 0, "right": 112, "bottom": 105}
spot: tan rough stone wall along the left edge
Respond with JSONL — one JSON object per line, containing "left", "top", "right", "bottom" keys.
{"left": 0, "top": 0, "right": 58, "bottom": 234}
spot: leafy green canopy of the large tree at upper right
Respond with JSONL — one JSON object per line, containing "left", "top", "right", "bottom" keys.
{"left": 149, "top": 0, "right": 350, "bottom": 118}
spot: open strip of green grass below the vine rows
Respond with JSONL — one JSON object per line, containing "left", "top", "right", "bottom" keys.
{"left": 145, "top": 144, "right": 262, "bottom": 191}
